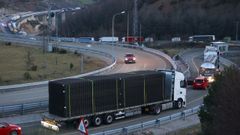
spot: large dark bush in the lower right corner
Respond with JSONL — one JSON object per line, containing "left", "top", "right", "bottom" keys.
{"left": 199, "top": 67, "right": 240, "bottom": 135}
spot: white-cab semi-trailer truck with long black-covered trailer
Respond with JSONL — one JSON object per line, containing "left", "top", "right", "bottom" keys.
{"left": 41, "top": 70, "right": 186, "bottom": 131}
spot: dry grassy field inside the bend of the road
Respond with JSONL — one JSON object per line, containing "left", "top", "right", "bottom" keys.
{"left": 0, "top": 43, "right": 106, "bottom": 85}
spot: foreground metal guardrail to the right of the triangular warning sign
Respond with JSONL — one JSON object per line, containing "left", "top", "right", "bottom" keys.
{"left": 92, "top": 105, "right": 201, "bottom": 135}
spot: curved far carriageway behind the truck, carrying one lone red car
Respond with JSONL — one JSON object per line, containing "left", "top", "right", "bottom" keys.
{"left": 0, "top": 44, "right": 170, "bottom": 106}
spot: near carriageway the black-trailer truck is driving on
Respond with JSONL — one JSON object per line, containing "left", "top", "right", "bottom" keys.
{"left": 17, "top": 50, "right": 207, "bottom": 135}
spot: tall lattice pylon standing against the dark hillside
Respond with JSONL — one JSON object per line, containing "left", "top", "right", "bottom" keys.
{"left": 133, "top": 0, "right": 138, "bottom": 36}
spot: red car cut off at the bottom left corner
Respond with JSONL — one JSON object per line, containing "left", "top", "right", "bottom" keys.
{"left": 0, "top": 123, "right": 22, "bottom": 135}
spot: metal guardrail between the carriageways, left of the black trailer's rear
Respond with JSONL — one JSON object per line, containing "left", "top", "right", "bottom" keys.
{"left": 0, "top": 100, "right": 48, "bottom": 118}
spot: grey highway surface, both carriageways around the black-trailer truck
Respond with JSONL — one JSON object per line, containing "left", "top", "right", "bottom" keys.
{"left": 0, "top": 10, "right": 207, "bottom": 135}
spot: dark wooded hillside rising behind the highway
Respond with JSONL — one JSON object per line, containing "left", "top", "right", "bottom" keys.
{"left": 62, "top": 0, "right": 240, "bottom": 39}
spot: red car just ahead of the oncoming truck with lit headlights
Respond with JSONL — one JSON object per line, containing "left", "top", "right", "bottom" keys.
{"left": 193, "top": 76, "right": 208, "bottom": 89}
